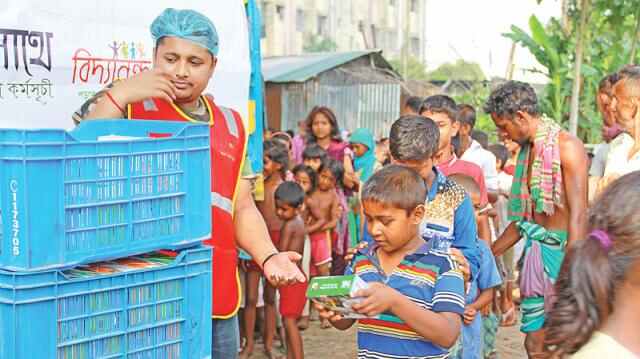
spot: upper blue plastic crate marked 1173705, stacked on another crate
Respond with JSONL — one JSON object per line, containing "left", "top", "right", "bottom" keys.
{"left": 0, "top": 120, "right": 211, "bottom": 270}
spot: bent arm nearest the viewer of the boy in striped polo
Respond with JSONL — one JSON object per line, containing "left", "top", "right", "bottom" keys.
{"left": 353, "top": 278, "right": 464, "bottom": 348}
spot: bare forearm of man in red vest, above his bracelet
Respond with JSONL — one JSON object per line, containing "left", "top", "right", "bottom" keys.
{"left": 233, "top": 205, "right": 277, "bottom": 265}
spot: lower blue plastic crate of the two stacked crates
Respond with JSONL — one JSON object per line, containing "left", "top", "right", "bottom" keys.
{"left": 0, "top": 246, "right": 211, "bottom": 359}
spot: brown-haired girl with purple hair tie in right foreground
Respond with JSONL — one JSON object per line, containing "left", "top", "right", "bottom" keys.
{"left": 546, "top": 172, "right": 640, "bottom": 359}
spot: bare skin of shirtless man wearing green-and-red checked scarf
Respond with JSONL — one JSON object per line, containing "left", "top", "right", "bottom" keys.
{"left": 491, "top": 111, "right": 587, "bottom": 358}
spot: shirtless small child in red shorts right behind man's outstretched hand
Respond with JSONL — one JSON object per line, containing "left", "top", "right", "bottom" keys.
{"left": 275, "top": 182, "right": 307, "bottom": 359}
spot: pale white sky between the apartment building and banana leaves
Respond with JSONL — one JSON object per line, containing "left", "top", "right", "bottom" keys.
{"left": 426, "top": 0, "right": 560, "bottom": 83}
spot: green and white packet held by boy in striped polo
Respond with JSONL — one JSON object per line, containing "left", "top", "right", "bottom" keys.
{"left": 307, "top": 275, "right": 368, "bottom": 319}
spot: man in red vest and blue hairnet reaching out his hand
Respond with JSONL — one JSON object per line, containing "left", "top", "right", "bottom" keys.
{"left": 74, "top": 9, "right": 305, "bottom": 359}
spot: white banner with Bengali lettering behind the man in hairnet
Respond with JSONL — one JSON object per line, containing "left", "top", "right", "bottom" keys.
{"left": 0, "top": 0, "right": 251, "bottom": 129}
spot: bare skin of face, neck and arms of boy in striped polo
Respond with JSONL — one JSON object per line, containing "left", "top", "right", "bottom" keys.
{"left": 315, "top": 201, "right": 461, "bottom": 348}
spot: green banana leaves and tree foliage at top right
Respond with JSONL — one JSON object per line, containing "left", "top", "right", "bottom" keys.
{"left": 504, "top": 0, "right": 640, "bottom": 142}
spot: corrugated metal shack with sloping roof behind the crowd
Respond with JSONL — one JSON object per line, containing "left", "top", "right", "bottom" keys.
{"left": 262, "top": 50, "right": 403, "bottom": 137}
